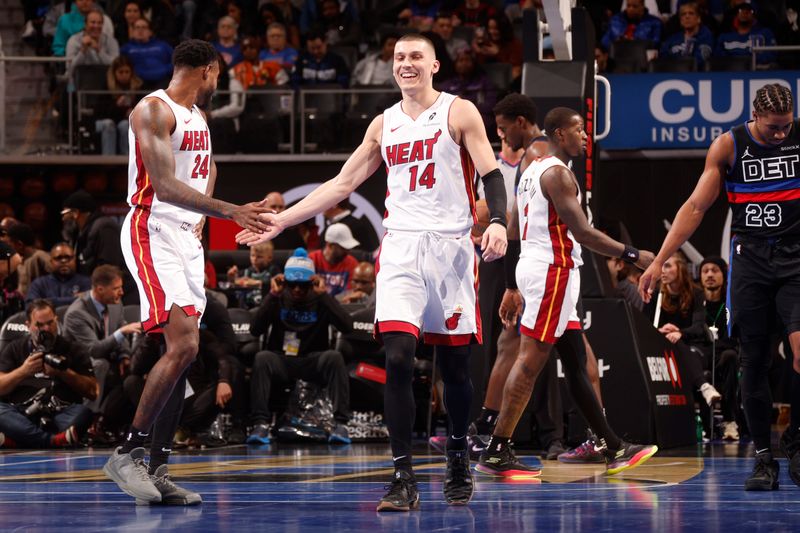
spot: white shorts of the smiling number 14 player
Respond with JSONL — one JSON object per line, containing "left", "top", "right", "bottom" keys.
{"left": 375, "top": 231, "right": 481, "bottom": 346}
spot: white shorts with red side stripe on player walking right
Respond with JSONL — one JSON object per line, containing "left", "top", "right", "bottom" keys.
{"left": 517, "top": 258, "right": 581, "bottom": 344}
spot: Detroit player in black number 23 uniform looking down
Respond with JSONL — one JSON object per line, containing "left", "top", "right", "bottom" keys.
{"left": 639, "top": 84, "right": 800, "bottom": 490}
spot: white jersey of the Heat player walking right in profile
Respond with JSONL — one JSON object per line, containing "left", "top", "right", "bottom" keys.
{"left": 517, "top": 156, "right": 583, "bottom": 268}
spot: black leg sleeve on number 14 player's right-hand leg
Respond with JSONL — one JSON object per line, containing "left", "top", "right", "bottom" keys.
{"left": 436, "top": 346, "right": 472, "bottom": 450}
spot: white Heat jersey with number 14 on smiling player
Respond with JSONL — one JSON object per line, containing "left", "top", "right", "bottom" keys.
{"left": 381, "top": 93, "right": 475, "bottom": 234}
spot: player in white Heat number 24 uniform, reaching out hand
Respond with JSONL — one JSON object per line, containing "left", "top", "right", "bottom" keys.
{"left": 103, "top": 39, "right": 269, "bottom": 505}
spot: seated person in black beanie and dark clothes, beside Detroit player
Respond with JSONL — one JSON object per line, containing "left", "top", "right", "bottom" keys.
{"left": 690, "top": 256, "right": 739, "bottom": 441}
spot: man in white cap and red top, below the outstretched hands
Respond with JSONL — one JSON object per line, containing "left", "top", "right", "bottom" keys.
{"left": 309, "top": 223, "right": 359, "bottom": 296}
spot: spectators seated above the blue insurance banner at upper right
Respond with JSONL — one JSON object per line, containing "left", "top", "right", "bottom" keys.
{"left": 587, "top": 0, "right": 800, "bottom": 72}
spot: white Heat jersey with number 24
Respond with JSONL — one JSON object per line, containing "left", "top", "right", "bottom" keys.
{"left": 128, "top": 90, "right": 211, "bottom": 224}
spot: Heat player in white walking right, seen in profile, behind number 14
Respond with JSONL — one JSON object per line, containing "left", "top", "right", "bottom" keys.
{"left": 476, "top": 107, "right": 658, "bottom": 477}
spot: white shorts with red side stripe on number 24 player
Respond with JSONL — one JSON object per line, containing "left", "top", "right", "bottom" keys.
{"left": 120, "top": 208, "right": 206, "bottom": 333}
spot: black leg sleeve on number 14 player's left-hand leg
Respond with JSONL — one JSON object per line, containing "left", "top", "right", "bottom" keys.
{"left": 383, "top": 333, "right": 417, "bottom": 473}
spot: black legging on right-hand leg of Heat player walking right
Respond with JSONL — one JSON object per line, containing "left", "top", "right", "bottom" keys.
{"left": 556, "top": 330, "right": 622, "bottom": 450}
